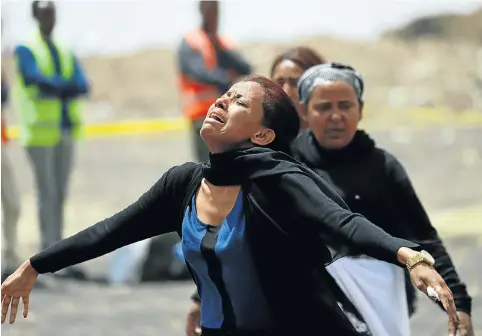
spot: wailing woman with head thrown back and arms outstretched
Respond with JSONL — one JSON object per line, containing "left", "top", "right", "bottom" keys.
{"left": 1, "top": 75, "right": 458, "bottom": 336}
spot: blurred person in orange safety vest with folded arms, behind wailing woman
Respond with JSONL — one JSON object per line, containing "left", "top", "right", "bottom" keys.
{"left": 178, "top": 1, "right": 251, "bottom": 162}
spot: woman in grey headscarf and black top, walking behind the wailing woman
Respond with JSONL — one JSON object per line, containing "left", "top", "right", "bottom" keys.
{"left": 293, "top": 63, "right": 473, "bottom": 336}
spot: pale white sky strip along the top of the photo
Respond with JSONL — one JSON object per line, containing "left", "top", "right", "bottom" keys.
{"left": 2, "top": 0, "right": 482, "bottom": 55}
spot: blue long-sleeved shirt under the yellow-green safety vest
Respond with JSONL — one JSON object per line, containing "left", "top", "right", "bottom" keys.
{"left": 15, "top": 40, "right": 89, "bottom": 129}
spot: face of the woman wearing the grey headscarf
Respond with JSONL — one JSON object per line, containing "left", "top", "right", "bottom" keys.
{"left": 306, "top": 81, "right": 363, "bottom": 149}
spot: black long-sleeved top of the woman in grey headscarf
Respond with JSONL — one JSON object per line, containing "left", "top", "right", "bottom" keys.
{"left": 293, "top": 131, "right": 471, "bottom": 314}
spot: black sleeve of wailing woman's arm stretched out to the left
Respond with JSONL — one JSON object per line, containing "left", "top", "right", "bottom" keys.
{"left": 30, "top": 166, "right": 189, "bottom": 273}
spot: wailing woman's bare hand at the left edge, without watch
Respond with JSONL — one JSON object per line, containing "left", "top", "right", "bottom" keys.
{"left": 2, "top": 260, "right": 38, "bottom": 324}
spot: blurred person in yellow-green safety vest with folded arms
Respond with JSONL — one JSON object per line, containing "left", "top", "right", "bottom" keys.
{"left": 15, "top": 1, "right": 89, "bottom": 279}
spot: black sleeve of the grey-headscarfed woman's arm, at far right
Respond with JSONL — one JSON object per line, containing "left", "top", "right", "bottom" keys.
{"left": 387, "top": 153, "right": 472, "bottom": 314}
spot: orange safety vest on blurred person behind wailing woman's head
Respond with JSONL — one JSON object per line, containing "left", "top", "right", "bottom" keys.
{"left": 179, "top": 29, "right": 232, "bottom": 120}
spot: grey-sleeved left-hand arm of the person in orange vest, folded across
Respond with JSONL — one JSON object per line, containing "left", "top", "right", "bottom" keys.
{"left": 178, "top": 39, "right": 232, "bottom": 87}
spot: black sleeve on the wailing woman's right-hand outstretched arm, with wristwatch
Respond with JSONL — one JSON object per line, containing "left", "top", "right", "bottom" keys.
{"left": 277, "top": 174, "right": 420, "bottom": 266}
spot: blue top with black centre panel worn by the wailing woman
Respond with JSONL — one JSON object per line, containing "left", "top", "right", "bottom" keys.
{"left": 182, "top": 193, "right": 273, "bottom": 330}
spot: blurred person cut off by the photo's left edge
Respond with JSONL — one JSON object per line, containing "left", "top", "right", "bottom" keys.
{"left": 1, "top": 70, "right": 20, "bottom": 282}
